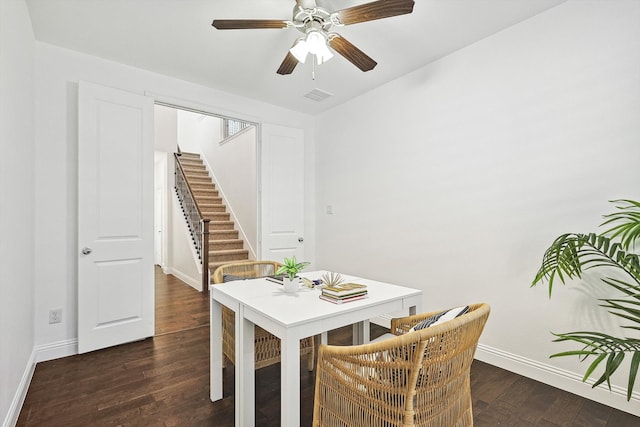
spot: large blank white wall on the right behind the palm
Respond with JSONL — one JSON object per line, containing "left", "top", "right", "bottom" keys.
{"left": 316, "top": 0, "right": 640, "bottom": 413}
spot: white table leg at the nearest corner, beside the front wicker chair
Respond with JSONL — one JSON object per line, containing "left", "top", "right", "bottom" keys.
{"left": 280, "top": 337, "right": 300, "bottom": 427}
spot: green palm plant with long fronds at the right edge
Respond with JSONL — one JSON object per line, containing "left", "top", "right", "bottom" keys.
{"left": 531, "top": 200, "right": 640, "bottom": 400}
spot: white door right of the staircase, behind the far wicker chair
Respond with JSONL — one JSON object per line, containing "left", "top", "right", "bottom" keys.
{"left": 260, "top": 124, "right": 304, "bottom": 261}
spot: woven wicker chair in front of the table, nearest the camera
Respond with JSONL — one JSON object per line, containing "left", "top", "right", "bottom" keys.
{"left": 313, "top": 303, "right": 490, "bottom": 427}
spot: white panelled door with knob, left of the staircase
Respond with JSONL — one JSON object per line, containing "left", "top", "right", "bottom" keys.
{"left": 78, "top": 82, "right": 154, "bottom": 353}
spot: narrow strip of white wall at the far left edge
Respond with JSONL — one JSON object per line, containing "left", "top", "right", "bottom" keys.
{"left": 0, "top": 0, "right": 38, "bottom": 426}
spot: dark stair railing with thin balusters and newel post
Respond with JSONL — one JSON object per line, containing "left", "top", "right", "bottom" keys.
{"left": 173, "top": 153, "right": 211, "bottom": 292}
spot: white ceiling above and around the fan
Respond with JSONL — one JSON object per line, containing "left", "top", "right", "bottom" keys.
{"left": 27, "top": 0, "right": 566, "bottom": 114}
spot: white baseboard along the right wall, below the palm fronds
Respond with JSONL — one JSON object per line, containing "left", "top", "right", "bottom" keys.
{"left": 475, "top": 344, "right": 640, "bottom": 416}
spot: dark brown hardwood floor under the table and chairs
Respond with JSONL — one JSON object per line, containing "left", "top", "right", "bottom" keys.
{"left": 17, "top": 270, "right": 640, "bottom": 427}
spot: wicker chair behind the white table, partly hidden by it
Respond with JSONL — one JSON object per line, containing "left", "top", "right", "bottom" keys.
{"left": 213, "top": 261, "right": 315, "bottom": 371}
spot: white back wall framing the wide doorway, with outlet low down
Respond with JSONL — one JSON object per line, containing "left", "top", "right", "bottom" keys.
{"left": 35, "top": 42, "right": 314, "bottom": 355}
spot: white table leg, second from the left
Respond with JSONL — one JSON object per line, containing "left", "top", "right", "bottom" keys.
{"left": 235, "top": 305, "right": 256, "bottom": 427}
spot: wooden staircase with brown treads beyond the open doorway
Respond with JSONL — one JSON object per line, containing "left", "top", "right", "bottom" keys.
{"left": 177, "top": 153, "right": 249, "bottom": 274}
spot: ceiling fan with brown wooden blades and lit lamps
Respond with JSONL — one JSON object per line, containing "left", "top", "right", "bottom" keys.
{"left": 212, "top": 0, "right": 414, "bottom": 75}
